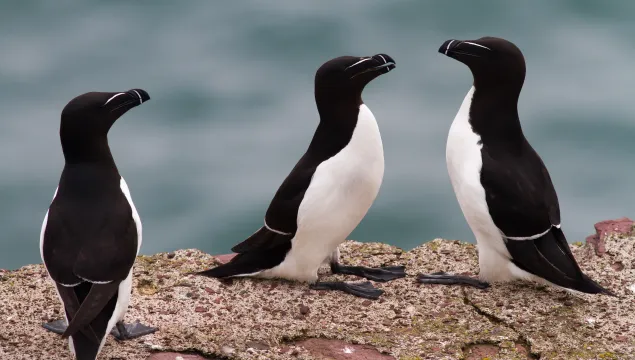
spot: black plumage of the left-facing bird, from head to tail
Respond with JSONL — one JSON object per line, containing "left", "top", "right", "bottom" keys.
{"left": 439, "top": 37, "right": 610, "bottom": 293}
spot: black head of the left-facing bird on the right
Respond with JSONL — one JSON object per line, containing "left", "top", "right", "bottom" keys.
{"left": 439, "top": 37, "right": 525, "bottom": 92}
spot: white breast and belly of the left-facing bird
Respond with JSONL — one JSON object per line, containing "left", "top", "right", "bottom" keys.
{"left": 445, "top": 87, "right": 512, "bottom": 281}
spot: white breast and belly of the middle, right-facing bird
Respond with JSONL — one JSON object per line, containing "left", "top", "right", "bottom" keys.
{"left": 262, "top": 104, "right": 384, "bottom": 281}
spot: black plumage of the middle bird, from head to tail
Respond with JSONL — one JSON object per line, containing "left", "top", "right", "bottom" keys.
{"left": 201, "top": 54, "right": 394, "bottom": 277}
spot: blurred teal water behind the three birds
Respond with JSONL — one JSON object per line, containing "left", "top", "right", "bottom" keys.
{"left": 0, "top": 0, "right": 635, "bottom": 268}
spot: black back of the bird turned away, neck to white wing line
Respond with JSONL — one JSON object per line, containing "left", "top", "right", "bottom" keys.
{"left": 43, "top": 163, "right": 137, "bottom": 285}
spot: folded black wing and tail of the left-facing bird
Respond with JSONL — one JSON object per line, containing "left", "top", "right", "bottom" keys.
{"left": 481, "top": 141, "right": 610, "bottom": 293}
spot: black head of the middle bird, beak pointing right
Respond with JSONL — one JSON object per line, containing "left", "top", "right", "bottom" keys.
{"left": 315, "top": 54, "right": 395, "bottom": 108}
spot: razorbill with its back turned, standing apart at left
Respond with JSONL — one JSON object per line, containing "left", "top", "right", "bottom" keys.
{"left": 40, "top": 89, "right": 156, "bottom": 360}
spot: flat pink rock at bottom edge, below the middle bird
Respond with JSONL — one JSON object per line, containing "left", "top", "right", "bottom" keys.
{"left": 295, "top": 339, "right": 395, "bottom": 360}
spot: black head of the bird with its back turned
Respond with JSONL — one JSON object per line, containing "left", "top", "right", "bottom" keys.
{"left": 60, "top": 89, "right": 150, "bottom": 162}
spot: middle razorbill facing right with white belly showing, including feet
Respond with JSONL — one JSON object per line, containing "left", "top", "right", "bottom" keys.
{"left": 199, "top": 54, "right": 405, "bottom": 298}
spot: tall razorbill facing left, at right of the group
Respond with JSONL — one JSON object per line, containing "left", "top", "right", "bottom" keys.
{"left": 419, "top": 37, "right": 612, "bottom": 294}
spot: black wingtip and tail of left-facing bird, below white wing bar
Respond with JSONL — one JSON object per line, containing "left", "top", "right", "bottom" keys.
{"left": 506, "top": 227, "right": 615, "bottom": 296}
